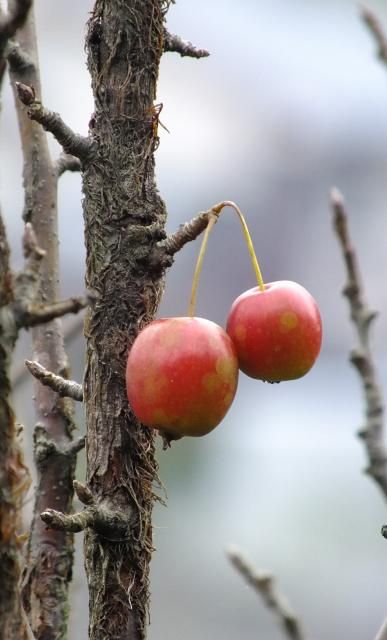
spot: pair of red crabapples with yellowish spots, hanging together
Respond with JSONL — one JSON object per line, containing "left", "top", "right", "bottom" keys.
{"left": 126, "top": 281, "right": 322, "bottom": 436}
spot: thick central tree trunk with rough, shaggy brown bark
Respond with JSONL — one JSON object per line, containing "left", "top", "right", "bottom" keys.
{"left": 83, "top": 0, "right": 168, "bottom": 640}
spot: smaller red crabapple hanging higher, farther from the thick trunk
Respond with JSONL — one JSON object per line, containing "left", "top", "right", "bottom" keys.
{"left": 227, "top": 280, "right": 322, "bottom": 382}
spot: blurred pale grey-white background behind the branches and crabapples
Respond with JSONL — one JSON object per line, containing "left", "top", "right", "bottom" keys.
{"left": 0, "top": 0, "right": 387, "bottom": 640}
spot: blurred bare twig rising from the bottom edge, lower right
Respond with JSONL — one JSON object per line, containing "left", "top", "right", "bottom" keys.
{"left": 227, "top": 548, "right": 305, "bottom": 640}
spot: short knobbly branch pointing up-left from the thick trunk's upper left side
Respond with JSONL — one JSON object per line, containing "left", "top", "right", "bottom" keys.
{"left": 16, "top": 82, "right": 93, "bottom": 162}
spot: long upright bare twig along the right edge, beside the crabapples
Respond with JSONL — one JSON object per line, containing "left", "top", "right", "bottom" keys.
{"left": 331, "top": 189, "right": 387, "bottom": 498}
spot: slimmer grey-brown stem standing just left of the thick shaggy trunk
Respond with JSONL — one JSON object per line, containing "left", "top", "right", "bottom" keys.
{"left": 9, "top": 6, "right": 83, "bottom": 640}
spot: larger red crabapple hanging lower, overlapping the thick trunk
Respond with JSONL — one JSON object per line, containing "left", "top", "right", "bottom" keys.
{"left": 126, "top": 317, "right": 239, "bottom": 436}
